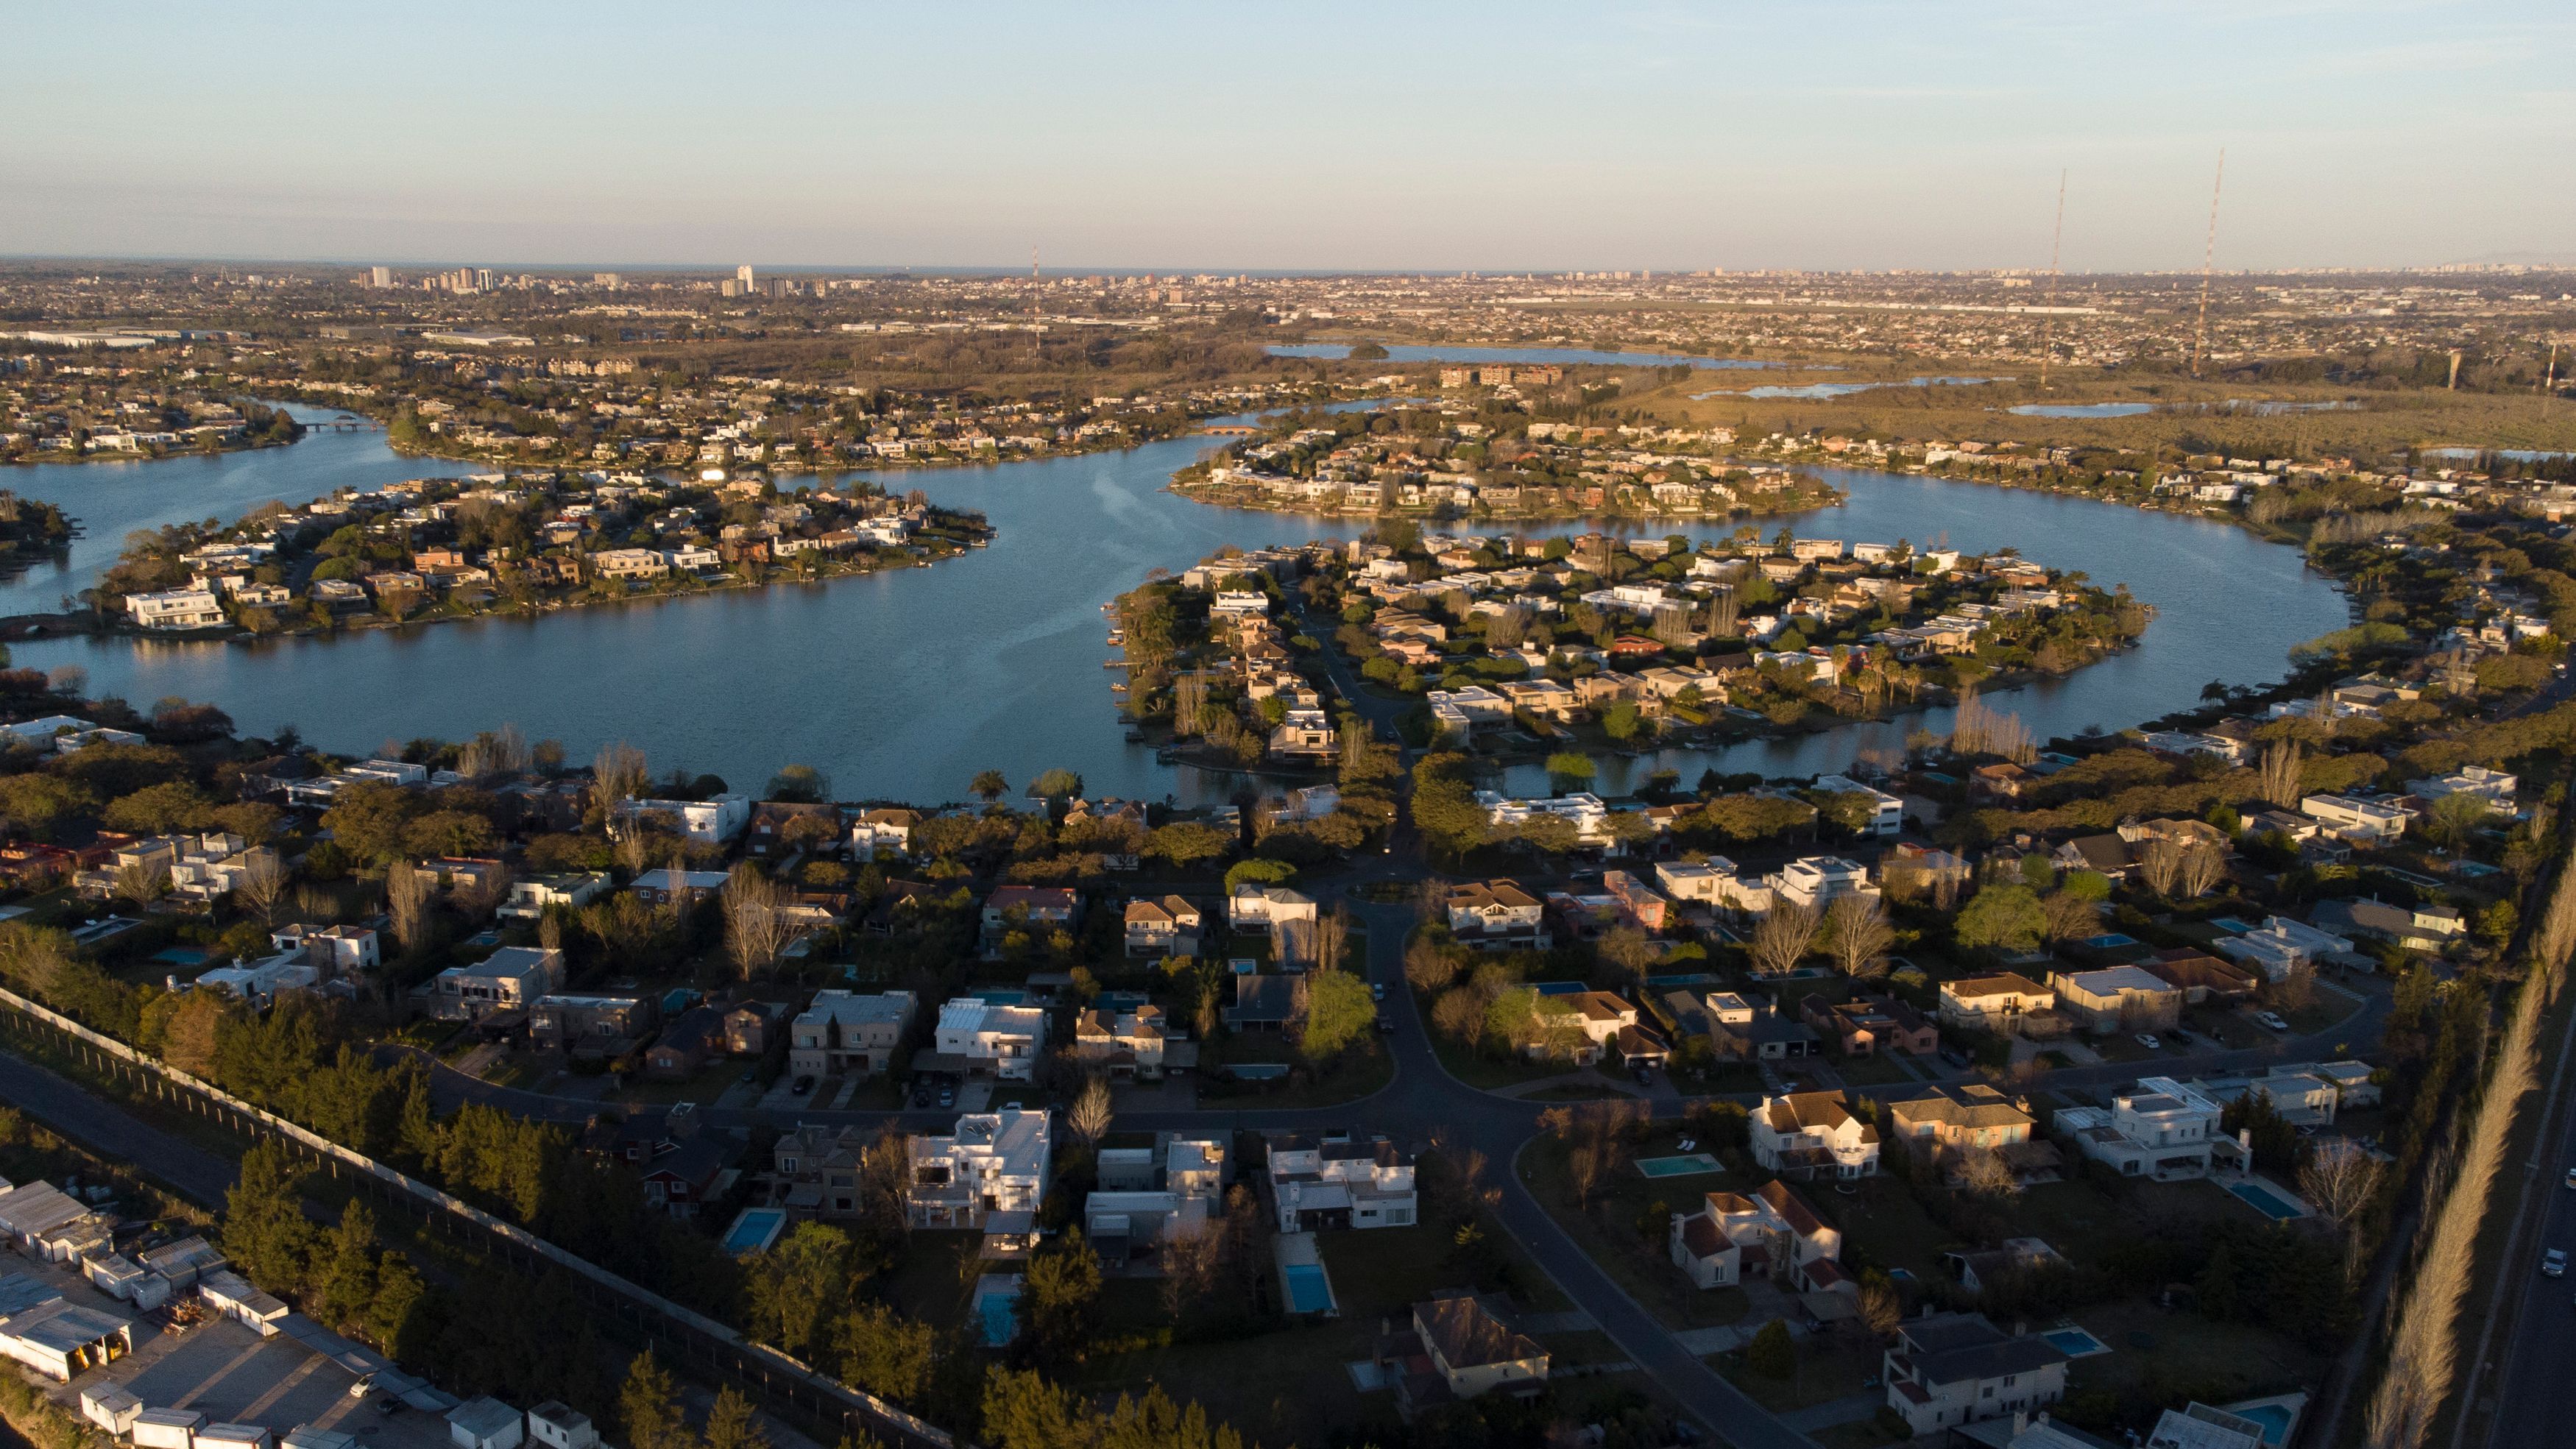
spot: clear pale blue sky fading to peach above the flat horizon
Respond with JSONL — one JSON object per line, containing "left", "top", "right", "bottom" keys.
{"left": 0, "top": 0, "right": 2576, "bottom": 270}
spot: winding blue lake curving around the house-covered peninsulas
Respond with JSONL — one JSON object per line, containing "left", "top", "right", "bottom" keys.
{"left": 10, "top": 414, "right": 2347, "bottom": 803}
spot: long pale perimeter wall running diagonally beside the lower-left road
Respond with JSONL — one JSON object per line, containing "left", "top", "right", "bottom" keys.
{"left": 0, "top": 988, "right": 972, "bottom": 1449}
